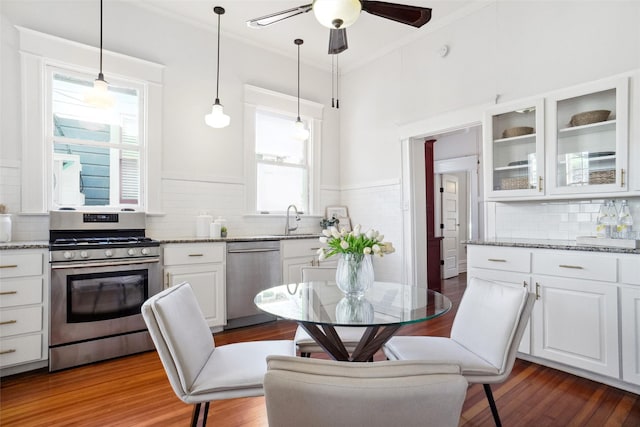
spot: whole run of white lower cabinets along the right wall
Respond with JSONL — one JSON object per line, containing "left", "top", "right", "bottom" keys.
{"left": 468, "top": 245, "right": 640, "bottom": 390}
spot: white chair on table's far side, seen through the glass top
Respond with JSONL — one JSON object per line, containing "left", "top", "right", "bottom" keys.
{"left": 293, "top": 267, "right": 366, "bottom": 357}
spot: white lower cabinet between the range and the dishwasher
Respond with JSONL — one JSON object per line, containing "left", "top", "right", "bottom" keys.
{"left": 163, "top": 243, "right": 226, "bottom": 328}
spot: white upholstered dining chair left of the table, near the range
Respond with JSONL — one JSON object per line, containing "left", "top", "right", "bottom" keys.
{"left": 142, "top": 283, "right": 295, "bottom": 426}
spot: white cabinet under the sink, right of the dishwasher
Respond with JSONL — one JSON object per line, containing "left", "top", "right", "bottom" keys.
{"left": 280, "top": 238, "right": 338, "bottom": 283}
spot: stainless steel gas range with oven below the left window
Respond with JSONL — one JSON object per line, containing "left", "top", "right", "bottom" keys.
{"left": 49, "top": 211, "right": 162, "bottom": 371}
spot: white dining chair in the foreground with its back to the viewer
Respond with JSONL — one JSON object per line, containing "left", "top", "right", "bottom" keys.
{"left": 264, "top": 356, "right": 467, "bottom": 427}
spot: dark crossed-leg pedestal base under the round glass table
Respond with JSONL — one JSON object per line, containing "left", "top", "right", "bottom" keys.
{"left": 298, "top": 322, "right": 402, "bottom": 362}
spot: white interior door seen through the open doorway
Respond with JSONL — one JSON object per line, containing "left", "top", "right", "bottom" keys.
{"left": 440, "top": 174, "right": 460, "bottom": 279}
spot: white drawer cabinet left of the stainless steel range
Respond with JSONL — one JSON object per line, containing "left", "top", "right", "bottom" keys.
{"left": 0, "top": 249, "right": 49, "bottom": 375}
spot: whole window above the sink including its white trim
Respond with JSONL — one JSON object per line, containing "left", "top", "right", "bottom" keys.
{"left": 245, "top": 85, "right": 323, "bottom": 214}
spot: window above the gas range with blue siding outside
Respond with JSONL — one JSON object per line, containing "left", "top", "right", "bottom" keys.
{"left": 49, "top": 67, "right": 144, "bottom": 208}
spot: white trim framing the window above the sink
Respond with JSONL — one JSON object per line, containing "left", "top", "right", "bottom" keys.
{"left": 244, "top": 84, "right": 324, "bottom": 215}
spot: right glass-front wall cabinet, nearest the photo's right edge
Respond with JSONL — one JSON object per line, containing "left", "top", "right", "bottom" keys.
{"left": 547, "top": 78, "right": 629, "bottom": 194}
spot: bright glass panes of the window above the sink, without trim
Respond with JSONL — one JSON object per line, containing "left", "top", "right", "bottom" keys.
{"left": 255, "top": 110, "right": 311, "bottom": 212}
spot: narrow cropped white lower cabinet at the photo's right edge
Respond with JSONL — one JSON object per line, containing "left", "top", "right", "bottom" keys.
{"left": 619, "top": 255, "right": 640, "bottom": 385}
